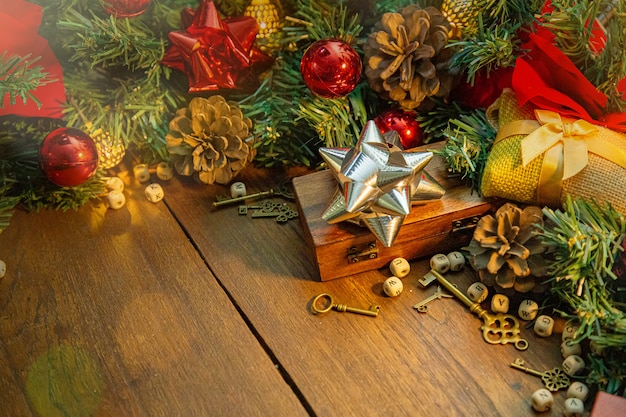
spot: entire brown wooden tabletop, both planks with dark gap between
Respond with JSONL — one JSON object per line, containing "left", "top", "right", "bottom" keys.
{"left": 0, "top": 164, "right": 565, "bottom": 417}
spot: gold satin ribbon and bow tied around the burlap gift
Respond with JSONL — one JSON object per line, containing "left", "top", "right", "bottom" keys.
{"left": 496, "top": 110, "right": 626, "bottom": 206}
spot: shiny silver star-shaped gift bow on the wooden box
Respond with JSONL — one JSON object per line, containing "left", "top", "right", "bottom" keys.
{"left": 320, "top": 121, "right": 443, "bottom": 247}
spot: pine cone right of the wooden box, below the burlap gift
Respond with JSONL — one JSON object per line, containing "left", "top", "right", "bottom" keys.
{"left": 465, "top": 203, "right": 546, "bottom": 293}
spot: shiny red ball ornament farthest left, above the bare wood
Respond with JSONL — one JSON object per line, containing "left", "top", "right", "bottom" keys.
{"left": 39, "top": 127, "right": 98, "bottom": 187}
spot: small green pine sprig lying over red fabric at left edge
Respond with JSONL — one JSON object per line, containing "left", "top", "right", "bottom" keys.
{"left": 0, "top": 51, "right": 57, "bottom": 108}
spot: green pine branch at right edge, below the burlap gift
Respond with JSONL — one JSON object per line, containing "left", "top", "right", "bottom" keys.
{"left": 538, "top": 198, "right": 626, "bottom": 393}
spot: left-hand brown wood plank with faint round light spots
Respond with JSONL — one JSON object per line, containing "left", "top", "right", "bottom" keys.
{"left": 0, "top": 170, "right": 308, "bottom": 417}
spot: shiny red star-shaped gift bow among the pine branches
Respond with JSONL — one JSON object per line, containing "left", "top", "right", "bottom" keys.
{"left": 161, "top": 0, "right": 272, "bottom": 93}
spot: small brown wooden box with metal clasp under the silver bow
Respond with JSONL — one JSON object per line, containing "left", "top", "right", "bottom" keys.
{"left": 293, "top": 144, "right": 501, "bottom": 281}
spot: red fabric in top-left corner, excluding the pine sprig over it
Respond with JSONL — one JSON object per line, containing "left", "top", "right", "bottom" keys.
{"left": 0, "top": 0, "right": 65, "bottom": 119}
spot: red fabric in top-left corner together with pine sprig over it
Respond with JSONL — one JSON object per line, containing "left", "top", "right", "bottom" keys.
{"left": 0, "top": 0, "right": 65, "bottom": 118}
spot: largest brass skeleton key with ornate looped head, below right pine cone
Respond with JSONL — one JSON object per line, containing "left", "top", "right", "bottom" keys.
{"left": 429, "top": 269, "right": 528, "bottom": 350}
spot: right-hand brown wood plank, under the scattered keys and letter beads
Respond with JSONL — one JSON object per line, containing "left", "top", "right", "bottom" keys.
{"left": 165, "top": 169, "right": 565, "bottom": 417}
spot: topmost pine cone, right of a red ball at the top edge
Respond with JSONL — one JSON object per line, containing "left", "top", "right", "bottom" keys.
{"left": 363, "top": 4, "right": 452, "bottom": 109}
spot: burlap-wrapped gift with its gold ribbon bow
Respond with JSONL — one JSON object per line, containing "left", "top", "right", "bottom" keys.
{"left": 481, "top": 90, "right": 626, "bottom": 214}
